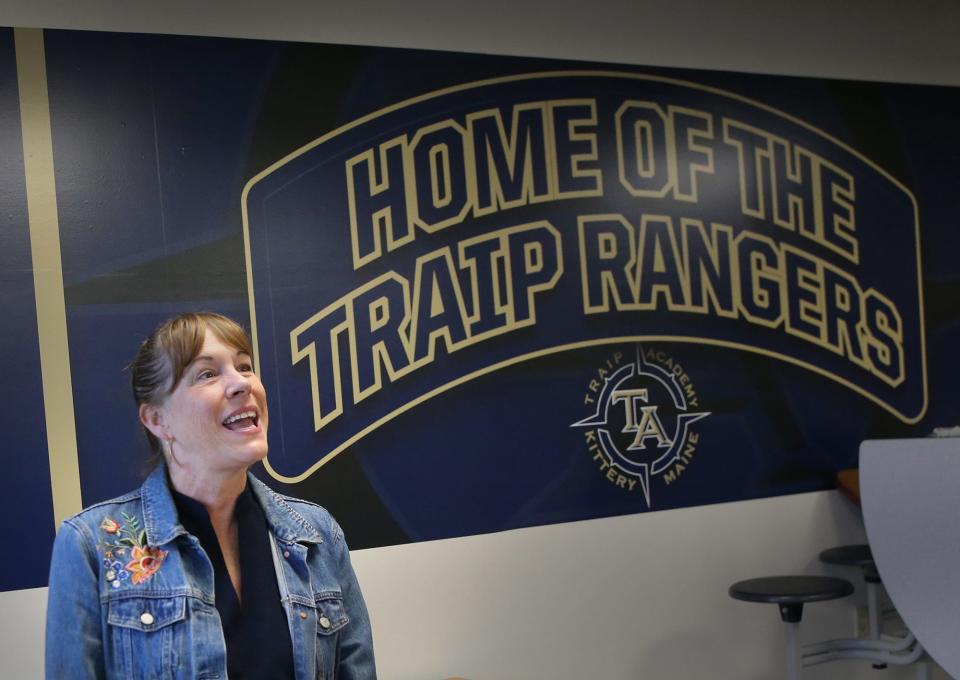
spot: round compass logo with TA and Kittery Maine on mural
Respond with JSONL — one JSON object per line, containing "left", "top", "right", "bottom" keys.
{"left": 570, "top": 345, "right": 710, "bottom": 507}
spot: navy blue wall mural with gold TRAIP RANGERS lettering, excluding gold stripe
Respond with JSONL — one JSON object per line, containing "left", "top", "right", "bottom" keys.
{"left": 0, "top": 26, "right": 960, "bottom": 587}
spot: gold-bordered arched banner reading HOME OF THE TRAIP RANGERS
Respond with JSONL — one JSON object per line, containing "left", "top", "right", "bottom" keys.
{"left": 243, "top": 72, "right": 927, "bottom": 482}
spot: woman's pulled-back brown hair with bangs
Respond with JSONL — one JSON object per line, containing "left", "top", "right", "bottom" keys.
{"left": 130, "top": 312, "right": 253, "bottom": 457}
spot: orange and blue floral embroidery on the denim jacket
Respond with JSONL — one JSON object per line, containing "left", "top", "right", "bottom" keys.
{"left": 97, "top": 512, "right": 167, "bottom": 588}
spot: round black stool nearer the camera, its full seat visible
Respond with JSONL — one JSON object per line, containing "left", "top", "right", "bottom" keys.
{"left": 729, "top": 576, "right": 853, "bottom": 680}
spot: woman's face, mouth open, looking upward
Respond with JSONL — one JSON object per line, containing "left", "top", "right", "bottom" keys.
{"left": 148, "top": 329, "right": 267, "bottom": 472}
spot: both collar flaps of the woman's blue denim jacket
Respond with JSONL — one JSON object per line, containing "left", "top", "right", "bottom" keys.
{"left": 140, "top": 462, "right": 323, "bottom": 546}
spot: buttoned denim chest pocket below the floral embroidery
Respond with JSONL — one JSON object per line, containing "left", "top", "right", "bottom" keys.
{"left": 106, "top": 595, "right": 187, "bottom": 678}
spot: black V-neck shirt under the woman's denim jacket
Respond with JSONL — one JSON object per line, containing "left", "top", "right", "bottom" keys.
{"left": 171, "top": 484, "right": 294, "bottom": 680}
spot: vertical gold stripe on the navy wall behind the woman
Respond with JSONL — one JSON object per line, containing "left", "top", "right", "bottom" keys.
{"left": 14, "top": 28, "right": 83, "bottom": 526}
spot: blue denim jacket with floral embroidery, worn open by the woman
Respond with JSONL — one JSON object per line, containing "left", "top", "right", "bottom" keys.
{"left": 46, "top": 465, "right": 376, "bottom": 680}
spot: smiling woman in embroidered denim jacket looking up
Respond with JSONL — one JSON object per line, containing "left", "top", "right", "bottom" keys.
{"left": 46, "top": 313, "right": 376, "bottom": 680}
